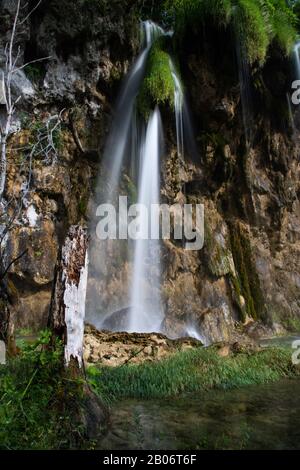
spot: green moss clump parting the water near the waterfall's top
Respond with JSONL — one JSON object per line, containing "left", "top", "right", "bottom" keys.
{"left": 137, "top": 38, "right": 174, "bottom": 118}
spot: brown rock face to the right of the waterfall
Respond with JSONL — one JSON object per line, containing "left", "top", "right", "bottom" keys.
{"left": 159, "top": 27, "right": 300, "bottom": 342}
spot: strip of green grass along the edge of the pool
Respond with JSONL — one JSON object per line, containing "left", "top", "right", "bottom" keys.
{"left": 88, "top": 347, "right": 300, "bottom": 403}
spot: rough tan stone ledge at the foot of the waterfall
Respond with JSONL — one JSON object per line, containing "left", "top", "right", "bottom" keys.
{"left": 84, "top": 325, "right": 202, "bottom": 367}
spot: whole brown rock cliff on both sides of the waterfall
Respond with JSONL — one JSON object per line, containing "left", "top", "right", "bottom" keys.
{"left": 0, "top": 0, "right": 300, "bottom": 344}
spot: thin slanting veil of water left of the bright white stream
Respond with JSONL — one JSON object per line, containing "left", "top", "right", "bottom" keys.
{"left": 87, "top": 21, "right": 168, "bottom": 329}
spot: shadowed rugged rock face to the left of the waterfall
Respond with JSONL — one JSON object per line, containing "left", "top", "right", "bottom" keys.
{"left": 0, "top": 0, "right": 139, "bottom": 330}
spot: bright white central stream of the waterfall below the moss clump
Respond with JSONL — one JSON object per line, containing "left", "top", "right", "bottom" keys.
{"left": 129, "top": 108, "right": 163, "bottom": 333}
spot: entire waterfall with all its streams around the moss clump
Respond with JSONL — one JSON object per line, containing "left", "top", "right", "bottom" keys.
{"left": 87, "top": 21, "right": 202, "bottom": 336}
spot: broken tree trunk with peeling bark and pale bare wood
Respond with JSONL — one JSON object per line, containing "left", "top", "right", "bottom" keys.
{"left": 48, "top": 226, "right": 88, "bottom": 367}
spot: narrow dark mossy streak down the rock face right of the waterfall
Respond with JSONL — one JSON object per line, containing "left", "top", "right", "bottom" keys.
{"left": 230, "top": 224, "right": 265, "bottom": 320}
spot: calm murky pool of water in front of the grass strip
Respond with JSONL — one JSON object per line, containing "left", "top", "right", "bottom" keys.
{"left": 99, "top": 380, "right": 300, "bottom": 450}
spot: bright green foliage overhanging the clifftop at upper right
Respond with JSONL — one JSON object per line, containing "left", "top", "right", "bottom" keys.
{"left": 164, "top": 0, "right": 298, "bottom": 64}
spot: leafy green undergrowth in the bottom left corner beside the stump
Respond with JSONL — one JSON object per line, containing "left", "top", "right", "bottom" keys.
{"left": 0, "top": 331, "right": 83, "bottom": 450}
